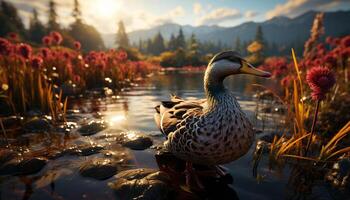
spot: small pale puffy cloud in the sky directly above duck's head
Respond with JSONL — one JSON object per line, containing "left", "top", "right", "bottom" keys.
{"left": 196, "top": 8, "right": 242, "bottom": 25}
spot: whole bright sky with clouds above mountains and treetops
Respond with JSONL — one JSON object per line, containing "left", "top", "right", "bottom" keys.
{"left": 7, "top": 0, "right": 350, "bottom": 33}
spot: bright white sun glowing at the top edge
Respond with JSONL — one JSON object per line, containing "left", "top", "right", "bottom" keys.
{"left": 95, "top": 0, "right": 121, "bottom": 17}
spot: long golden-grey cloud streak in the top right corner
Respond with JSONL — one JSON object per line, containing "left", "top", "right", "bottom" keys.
{"left": 266, "top": 0, "right": 350, "bottom": 19}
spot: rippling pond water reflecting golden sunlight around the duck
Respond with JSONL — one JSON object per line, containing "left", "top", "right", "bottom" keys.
{"left": 0, "top": 72, "right": 342, "bottom": 200}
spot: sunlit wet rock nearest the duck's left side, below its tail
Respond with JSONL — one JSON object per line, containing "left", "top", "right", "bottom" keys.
{"left": 120, "top": 132, "right": 153, "bottom": 150}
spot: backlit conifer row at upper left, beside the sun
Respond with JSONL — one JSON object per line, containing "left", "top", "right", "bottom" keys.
{"left": 0, "top": 0, "right": 105, "bottom": 51}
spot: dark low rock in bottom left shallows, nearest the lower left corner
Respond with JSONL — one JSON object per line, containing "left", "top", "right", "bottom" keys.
{"left": 17, "top": 158, "right": 47, "bottom": 175}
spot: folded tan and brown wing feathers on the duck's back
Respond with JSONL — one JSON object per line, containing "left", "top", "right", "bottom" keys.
{"left": 154, "top": 95, "right": 206, "bottom": 136}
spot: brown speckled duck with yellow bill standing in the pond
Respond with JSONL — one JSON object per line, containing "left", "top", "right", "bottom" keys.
{"left": 154, "top": 51, "right": 271, "bottom": 188}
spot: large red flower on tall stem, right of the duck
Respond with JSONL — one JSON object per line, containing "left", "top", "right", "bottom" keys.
{"left": 306, "top": 67, "right": 335, "bottom": 100}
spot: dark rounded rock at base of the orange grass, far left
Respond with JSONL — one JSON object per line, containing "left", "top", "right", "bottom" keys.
{"left": 23, "top": 117, "right": 52, "bottom": 133}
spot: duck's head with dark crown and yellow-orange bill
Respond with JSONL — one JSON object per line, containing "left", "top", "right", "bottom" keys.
{"left": 208, "top": 51, "right": 271, "bottom": 79}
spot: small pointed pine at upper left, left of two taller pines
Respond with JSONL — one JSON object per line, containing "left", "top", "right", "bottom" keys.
{"left": 28, "top": 9, "right": 46, "bottom": 43}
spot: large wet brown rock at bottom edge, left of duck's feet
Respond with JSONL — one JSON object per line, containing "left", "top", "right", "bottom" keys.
{"left": 108, "top": 169, "right": 176, "bottom": 200}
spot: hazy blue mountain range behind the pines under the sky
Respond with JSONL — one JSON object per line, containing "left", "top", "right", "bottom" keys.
{"left": 103, "top": 11, "right": 350, "bottom": 47}
